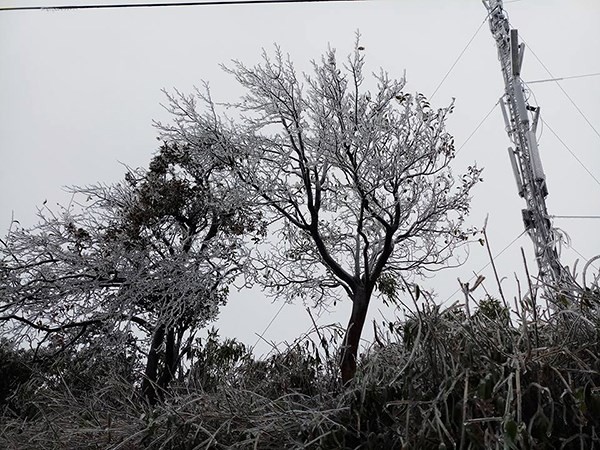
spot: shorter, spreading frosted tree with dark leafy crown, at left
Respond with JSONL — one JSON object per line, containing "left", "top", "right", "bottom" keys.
{"left": 0, "top": 144, "right": 262, "bottom": 402}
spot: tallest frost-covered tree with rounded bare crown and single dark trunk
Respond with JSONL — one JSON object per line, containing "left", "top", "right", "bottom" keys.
{"left": 159, "top": 43, "right": 479, "bottom": 382}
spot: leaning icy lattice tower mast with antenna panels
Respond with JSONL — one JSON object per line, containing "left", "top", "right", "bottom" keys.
{"left": 482, "top": 0, "right": 574, "bottom": 298}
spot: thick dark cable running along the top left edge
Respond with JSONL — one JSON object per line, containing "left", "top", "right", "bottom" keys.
{"left": 0, "top": 0, "right": 367, "bottom": 11}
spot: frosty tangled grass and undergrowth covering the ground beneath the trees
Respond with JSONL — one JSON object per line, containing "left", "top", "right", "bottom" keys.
{"left": 0, "top": 293, "right": 600, "bottom": 450}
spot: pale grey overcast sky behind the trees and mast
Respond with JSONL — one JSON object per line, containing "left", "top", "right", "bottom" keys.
{"left": 0, "top": 0, "right": 600, "bottom": 354}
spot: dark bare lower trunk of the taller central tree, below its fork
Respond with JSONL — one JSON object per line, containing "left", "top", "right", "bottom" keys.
{"left": 340, "top": 286, "right": 372, "bottom": 384}
